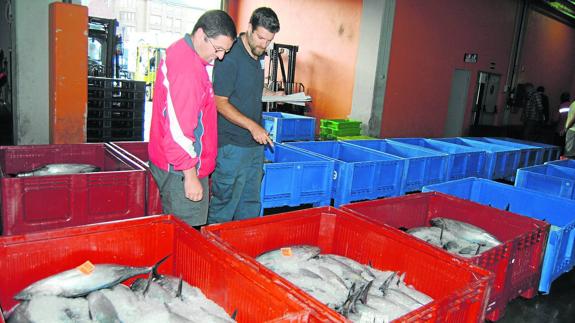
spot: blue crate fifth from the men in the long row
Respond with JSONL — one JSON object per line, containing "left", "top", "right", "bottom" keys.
{"left": 434, "top": 138, "right": 521, "bottom": 179}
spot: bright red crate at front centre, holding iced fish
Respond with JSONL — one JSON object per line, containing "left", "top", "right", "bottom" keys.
{"left": 202, "top": 207, "right": 493, "bottom": 322}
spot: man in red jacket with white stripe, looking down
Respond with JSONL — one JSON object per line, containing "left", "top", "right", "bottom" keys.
{"left": 148, "top": 10, "right": 236, "bottom": 226}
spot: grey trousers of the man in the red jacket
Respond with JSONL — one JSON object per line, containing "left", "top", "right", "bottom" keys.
{"left": 150, "top": 162, "right": 210, "bottom": 226}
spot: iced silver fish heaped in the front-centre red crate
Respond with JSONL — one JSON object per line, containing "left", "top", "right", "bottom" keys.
{"left": 256, "top": 246, "right": 433, "bottom": 322}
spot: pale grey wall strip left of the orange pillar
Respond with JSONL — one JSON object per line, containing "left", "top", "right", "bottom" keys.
{"left": 12, "top": 0, "right": 81, "bottom": 145}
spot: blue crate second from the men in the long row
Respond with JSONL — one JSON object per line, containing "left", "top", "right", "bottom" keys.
{"left": 287, "top": 141, "right": 405, "bottom": 207}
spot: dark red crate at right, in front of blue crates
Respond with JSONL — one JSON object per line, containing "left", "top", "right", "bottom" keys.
{"left": 342, "top": 193, "right": 549, "bottom": 321}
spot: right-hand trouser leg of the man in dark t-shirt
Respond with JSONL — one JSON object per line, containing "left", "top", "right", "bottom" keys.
{"left": 234, "top": 146, "right": 264, "bottom": 220}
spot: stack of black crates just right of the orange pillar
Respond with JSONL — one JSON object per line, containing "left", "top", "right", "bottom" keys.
{"left": 86, "top": 77, "right": 146, "bottom": 142}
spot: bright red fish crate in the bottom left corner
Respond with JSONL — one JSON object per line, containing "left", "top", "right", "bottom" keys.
{"left": 0, "top": 215, "right": 309, "bottom": 322}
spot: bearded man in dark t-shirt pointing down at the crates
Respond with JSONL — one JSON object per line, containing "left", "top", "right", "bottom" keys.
{"left": 208, "top": 7, "right": 280, "bottom": 223}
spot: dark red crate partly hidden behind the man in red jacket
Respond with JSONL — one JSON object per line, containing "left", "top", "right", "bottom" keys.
{"left": 110, "top": 141, "right": 163, "bottom": 215}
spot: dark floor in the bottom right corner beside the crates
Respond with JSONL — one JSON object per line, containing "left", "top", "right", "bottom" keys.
{"left": 497, "top": 270, "right": 575, "bottom": 323}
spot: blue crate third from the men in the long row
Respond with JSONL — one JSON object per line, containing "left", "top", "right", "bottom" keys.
{"left": 346, "top": 139, "right": 449, "bottom": 192}
